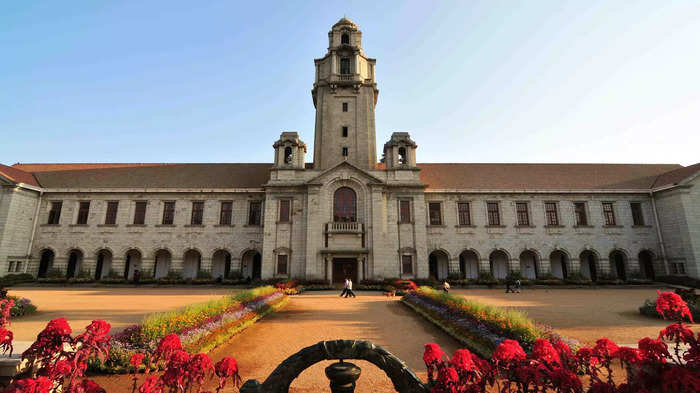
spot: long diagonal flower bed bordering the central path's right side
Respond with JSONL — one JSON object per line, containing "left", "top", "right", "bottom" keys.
{"left": 401, "top": 287, "right": 579, "bottom": 358}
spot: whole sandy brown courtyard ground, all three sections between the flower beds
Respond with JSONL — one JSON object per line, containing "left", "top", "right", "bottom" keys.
{"left": 11, "top": 287, "right": 697, "bottom": 392}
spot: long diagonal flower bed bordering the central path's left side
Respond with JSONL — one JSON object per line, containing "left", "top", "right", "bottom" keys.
{"left": 90, "top": 286, "right": 288, "bottom": 373}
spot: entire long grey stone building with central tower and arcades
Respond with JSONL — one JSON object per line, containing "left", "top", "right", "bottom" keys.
{"left": 0, "top": 18, "right": 700, "bottom": 282}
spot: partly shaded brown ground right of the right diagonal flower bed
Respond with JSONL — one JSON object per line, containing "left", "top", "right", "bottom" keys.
{"left": 450, "top": 288, "right": 700, "bottom": 345}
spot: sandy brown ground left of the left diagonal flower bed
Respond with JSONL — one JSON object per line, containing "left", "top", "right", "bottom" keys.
{"left": 10, "top": 287, "right": 236, "bottom": 341}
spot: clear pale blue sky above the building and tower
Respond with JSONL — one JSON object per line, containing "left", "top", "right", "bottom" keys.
{"left": 0, "top": 0, "right": 700, "bottom": 165}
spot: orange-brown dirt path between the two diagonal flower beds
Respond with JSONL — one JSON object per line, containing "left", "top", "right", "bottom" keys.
{"left": 96, "top": 292, "right": 459, "bottom": 393}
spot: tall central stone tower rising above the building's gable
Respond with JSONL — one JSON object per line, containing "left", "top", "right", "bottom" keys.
{"left": 311, "top": 18, "right": 379, "bottom": 170}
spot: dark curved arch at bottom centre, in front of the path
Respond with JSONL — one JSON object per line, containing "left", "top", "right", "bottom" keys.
{"left": 241, "top": 340, "right": 428, "bottom": 393}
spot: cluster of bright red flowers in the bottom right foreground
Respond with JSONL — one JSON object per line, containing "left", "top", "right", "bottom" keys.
{"left": 423, "top": 292, "right": 700, "bottom": 393}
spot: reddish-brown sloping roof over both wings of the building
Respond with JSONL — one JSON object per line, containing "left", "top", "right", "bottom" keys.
{"left": 8, "top": 163, "right": 700, "bottom": 191}
